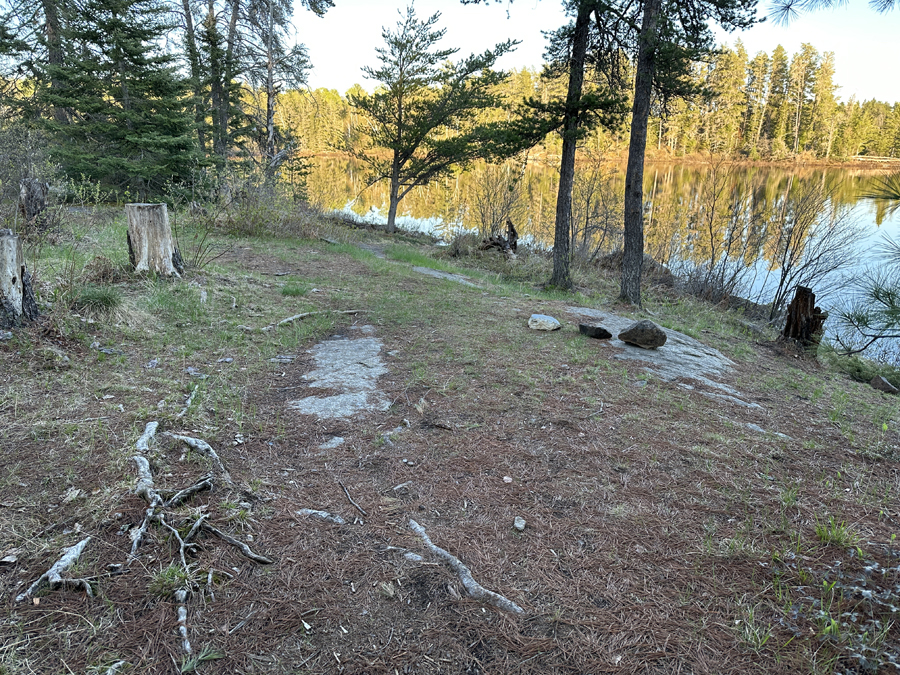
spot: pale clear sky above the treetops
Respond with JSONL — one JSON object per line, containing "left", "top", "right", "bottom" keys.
{"left": 294, "top": 0, "right": 900, "bottom": 103}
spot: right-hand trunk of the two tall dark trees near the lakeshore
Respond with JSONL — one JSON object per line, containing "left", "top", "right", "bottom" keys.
{"left": 619, "top": 0, "right": 661, "bottom": 306}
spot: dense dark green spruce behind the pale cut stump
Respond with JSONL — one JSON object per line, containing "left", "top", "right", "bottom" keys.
{"left": 40, "top": 0, "right": 198, "bottom": 199}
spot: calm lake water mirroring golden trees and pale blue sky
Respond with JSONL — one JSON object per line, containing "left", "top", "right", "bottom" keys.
{"left": 308, "top": 158, "right": 900, "bottom": 354}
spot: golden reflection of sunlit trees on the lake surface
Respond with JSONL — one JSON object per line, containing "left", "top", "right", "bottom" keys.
{"left": 307, "top": 157, "right": 896, "bottom": 246}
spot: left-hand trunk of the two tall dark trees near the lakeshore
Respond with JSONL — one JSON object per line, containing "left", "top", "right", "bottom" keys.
{"left": 550, "top": 0, "right": 592, "bottom": 288}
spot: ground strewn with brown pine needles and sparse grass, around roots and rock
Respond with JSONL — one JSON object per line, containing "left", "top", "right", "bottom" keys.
{"left": 0, "top": 234, "right": 900, "bottom": 675}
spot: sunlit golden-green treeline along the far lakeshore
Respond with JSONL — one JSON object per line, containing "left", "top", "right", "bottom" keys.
{"left": 279, "top": 41, "right": 900, "bottom": 163}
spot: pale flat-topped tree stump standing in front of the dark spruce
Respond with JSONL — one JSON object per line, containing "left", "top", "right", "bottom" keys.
{"left": 125, "top": 204, "right": 184, "bottom": 277}
